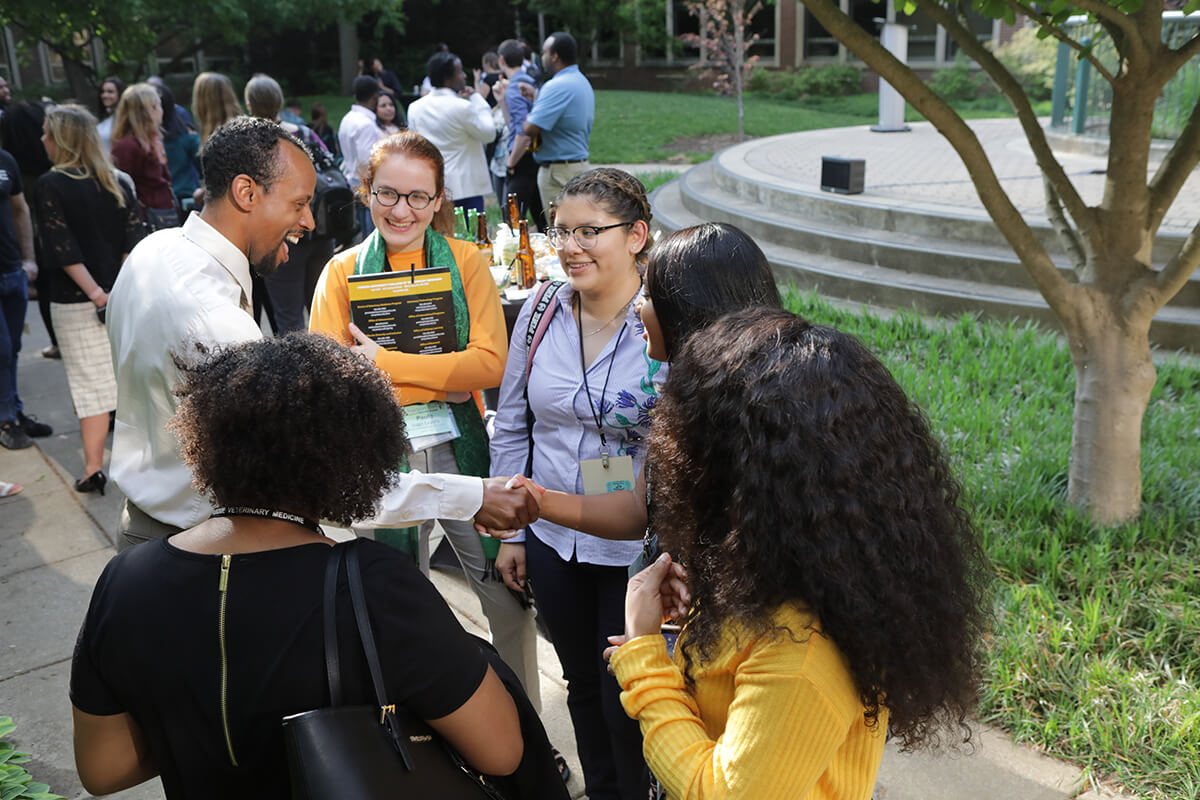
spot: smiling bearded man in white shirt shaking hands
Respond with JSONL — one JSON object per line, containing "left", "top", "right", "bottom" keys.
{"left": 108, "top": 116, "right": 536, "bottom": 548}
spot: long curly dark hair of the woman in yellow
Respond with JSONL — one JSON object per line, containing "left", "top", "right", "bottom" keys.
{"left": 648, "top": 308, "right": 989, "bottom": 748}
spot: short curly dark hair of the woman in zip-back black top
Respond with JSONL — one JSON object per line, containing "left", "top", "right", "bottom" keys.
{"left": 169, "top": 332, "right": 408, "bottom": 525}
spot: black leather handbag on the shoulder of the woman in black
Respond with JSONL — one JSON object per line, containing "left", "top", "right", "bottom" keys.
{"left": 283, "top": 542, "right": 505, "bottom": 800}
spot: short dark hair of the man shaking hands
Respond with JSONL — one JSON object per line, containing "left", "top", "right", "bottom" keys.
{"left": 200, "top": 116, "right": 312, "bottom": 200}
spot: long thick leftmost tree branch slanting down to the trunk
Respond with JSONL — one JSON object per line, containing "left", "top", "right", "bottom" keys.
{"left": 804, "top": 0, "right": 1087, "bottom": 320}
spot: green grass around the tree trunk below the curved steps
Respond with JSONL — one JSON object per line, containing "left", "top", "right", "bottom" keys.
{"left": 786, "top": 290, "right": 1200, "bottom": 799}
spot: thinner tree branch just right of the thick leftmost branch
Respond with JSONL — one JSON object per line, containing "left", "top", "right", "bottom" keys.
{"left": 917, "top": 0, "right": 1102, "bottom": 251}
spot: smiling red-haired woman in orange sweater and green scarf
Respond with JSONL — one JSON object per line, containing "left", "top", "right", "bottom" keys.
{"left": 308, "top": 131, "right": 541, "bottom": 738}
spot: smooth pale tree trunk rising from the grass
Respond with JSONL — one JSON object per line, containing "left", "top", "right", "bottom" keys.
{"left": 1067, "top": 291, "right": 1156, "bottom": 525}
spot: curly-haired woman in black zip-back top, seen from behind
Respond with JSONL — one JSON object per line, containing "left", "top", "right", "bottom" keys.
{"left": 71, "top": 333, "right": 552, "bottom": 800}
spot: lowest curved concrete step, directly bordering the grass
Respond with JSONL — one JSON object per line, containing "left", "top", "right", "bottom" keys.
{"left": 650, "top": 176, "right": 1200, "bottom": 350}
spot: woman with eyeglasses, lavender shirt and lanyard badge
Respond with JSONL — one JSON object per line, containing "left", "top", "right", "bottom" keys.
{"left": 492, "top": 168, "right": 666, "bottom": 800}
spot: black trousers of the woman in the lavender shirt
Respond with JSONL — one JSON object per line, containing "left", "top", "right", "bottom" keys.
{"left": 526, "top": 529, "right": 649, "bottom": 800}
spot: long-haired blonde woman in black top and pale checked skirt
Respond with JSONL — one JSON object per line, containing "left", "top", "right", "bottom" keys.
{"left": 37, "top": 106, "right": 142, "bottom": 494}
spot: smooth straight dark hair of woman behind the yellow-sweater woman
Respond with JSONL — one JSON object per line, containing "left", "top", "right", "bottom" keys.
{"left": 646, "top": 222, "right": 784, "bottom": 359}
